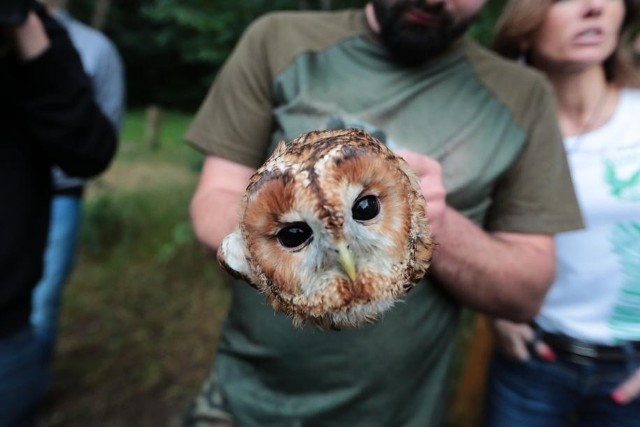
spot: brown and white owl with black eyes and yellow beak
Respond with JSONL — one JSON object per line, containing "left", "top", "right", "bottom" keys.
{"left": 218, "top": 129, "right": 433, "bottom": 329}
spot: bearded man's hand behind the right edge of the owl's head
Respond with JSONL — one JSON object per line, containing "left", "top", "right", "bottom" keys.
{"left": 395, "top": 150, "right": 446, "bottom": 241}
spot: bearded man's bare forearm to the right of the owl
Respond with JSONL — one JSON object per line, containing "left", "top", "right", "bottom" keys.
{"left": 432, "top": 208, "right": 554, "bottom": 321}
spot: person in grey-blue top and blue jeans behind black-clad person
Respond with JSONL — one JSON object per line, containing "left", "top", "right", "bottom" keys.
{"left": 31, "top": 0, "right": 125, "bottom": 382}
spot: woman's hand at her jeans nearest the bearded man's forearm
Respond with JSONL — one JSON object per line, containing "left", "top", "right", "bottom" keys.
{"left": 491, "top": 319, "right": 556, "bottom": 362}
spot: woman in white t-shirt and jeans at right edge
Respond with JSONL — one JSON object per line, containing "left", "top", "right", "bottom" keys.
{"left": 486, "top": 0, "right": 640, "bottom": 427}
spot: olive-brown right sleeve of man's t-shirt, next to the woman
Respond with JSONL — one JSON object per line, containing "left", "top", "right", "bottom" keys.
{"left": 485, "top": 80, "right": 583, "bottom": 234}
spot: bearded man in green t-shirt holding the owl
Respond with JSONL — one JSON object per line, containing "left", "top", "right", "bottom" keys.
{"left": 180, "top": 0, "right": 582, "bottom": 427}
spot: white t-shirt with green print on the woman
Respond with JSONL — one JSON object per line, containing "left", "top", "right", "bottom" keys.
{"left": 537, "top": 90, "right": 640, "bottom": 344}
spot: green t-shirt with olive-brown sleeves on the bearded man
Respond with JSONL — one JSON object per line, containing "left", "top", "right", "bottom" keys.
{"left": 187, "top": 10, "right": 581, "bottom": 427}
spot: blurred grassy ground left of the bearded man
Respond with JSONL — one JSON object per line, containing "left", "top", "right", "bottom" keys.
{"left": 43, "top": 111, "right": 229, "bottom": 427}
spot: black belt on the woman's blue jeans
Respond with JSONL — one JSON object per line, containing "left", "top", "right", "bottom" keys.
{"left": 540, "top": 331, "right": 640, "bottom": 362}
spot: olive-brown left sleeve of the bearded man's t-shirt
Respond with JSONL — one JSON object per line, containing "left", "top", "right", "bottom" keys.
{"left": 186, "top": 19, "right": 273, "bottom": 167}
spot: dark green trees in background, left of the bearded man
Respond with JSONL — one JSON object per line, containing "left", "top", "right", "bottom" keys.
{"left": 68, "top": 0, "right": 364, "bottom": 111}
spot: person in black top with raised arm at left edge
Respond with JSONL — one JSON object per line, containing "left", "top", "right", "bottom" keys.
{"left": 0, "top": 2, "right": 116, "bottom": 427}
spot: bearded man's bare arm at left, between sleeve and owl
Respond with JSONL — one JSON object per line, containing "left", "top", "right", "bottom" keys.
{"left": 190, "top": 156, "right": 255, "bottom": 252}
